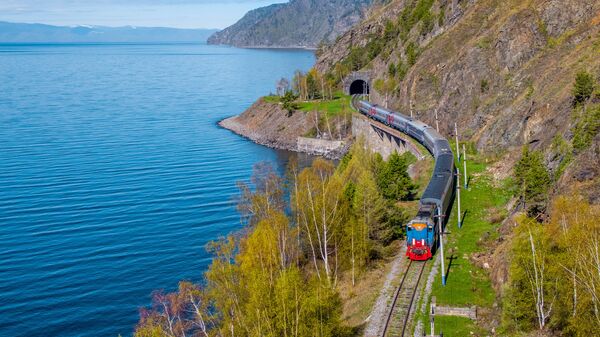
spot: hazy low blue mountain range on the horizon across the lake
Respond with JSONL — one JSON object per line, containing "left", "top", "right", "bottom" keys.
{"left": 0, "top": 22, "right": 217, "bottom": 43}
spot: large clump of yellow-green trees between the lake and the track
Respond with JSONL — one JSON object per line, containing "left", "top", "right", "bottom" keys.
{"left": 135, "top": 141, "right": 418, "bottom": 337}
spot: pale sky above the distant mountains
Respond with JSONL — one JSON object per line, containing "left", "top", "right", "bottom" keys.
{"left": 0, "top": 0, "right": 286, "bottom": 29}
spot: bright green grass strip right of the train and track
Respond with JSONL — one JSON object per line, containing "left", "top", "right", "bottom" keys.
{"left": 424, "top": 142, "right": 510, "bottom": 337}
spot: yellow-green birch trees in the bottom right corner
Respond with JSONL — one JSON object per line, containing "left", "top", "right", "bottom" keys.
{"left": 503, "top": 196, "right": 600, "bottom": 336}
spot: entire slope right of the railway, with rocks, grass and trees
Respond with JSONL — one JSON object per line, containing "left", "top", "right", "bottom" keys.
{"left": 315, "top": 0, "right": 600, "bottom": 336}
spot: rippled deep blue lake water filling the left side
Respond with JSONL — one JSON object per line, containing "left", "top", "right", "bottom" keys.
{"left": 0, "top": 45, "right": 314, "bottom": 336}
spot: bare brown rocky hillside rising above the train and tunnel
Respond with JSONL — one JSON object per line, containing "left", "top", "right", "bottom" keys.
{"left": 316, "top": 0, "right": 600, "bottom": 202}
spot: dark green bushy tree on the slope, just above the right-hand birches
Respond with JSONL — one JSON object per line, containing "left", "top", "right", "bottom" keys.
{"left": 514, "top": 146, "right": 551, "bottom": 217}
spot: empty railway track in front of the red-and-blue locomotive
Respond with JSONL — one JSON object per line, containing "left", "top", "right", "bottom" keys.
{"left": 382, "top": 261, "right": 427, "bottom": 337}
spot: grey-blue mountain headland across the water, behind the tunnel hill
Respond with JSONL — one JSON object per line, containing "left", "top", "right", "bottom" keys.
{"left": 208, "top": 0, "right": 373, "bottom": 48}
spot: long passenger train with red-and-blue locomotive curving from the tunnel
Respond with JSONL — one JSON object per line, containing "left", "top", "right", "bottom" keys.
{"left": 352, "top": 96, "right": 456, "bottom": 261}
